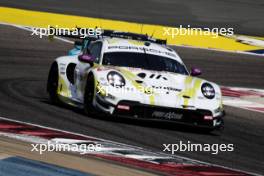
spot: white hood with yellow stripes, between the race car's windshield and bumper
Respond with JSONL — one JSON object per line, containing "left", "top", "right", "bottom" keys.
{"left": 93, "top": 66, "right": 221, "bottom": 108}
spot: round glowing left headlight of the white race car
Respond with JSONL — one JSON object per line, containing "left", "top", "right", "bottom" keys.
{"left": 107, "top": 71, "right": 126, "bottom": 87}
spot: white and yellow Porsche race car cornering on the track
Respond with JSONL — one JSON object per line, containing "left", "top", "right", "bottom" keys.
{"left": 47, "top": 32, "right": 224, "bottom": 129}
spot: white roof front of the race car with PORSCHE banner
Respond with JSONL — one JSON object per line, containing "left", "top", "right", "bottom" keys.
{"left": 99, "top": 37, "right": 182, "bottom": 63}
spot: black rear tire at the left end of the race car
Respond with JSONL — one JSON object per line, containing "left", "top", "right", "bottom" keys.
{"left": 47, "top": 62, "right": 60, "bottom": 104}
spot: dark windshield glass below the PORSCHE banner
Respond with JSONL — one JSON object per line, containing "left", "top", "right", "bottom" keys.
{"left": 103, "top": 52, "right": 188, "bottom": 75}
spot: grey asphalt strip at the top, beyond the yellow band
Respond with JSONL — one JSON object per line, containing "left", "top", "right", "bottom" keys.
{"left": 0, "top": 0, "right": 264, "bottom": 36}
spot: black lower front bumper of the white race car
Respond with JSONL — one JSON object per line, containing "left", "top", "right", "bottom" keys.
{"left": 113, "top": 101, "right": 224, "bottom": 128}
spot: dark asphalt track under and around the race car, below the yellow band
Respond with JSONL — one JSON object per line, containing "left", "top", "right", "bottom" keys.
{"left": 0, "top": 25, "right": 264, "bottom": 174}
